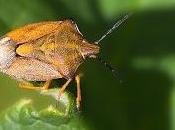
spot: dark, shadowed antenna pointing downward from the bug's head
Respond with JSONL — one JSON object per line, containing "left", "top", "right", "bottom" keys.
{"left": 97, "top": 56, "right": 123, "bottom": 83}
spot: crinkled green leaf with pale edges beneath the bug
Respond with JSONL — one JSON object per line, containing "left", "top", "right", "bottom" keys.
{"left": 0, "top": 89, "right": 88, "bottom": 130}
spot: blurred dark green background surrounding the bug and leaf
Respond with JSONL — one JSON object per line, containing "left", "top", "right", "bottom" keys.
{"left": 0, "top": 0, "right": 175, "bottom": 130}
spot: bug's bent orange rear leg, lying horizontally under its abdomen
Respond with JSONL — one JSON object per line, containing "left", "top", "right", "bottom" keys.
{"left": 18, "top": 80, "right": 51, "bottom": 90}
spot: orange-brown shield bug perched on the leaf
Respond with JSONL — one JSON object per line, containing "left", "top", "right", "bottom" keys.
{"left": 0, "top": 15, "right": 129, "bottom": 107}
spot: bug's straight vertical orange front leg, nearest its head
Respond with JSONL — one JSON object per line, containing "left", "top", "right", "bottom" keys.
{"left": 75, "top": 75, "right": 81, "bottom": 109}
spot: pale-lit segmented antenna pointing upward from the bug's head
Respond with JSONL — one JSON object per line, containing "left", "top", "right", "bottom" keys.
{"left": 95, "top": 13, "right": 131, "bottom": 44}
